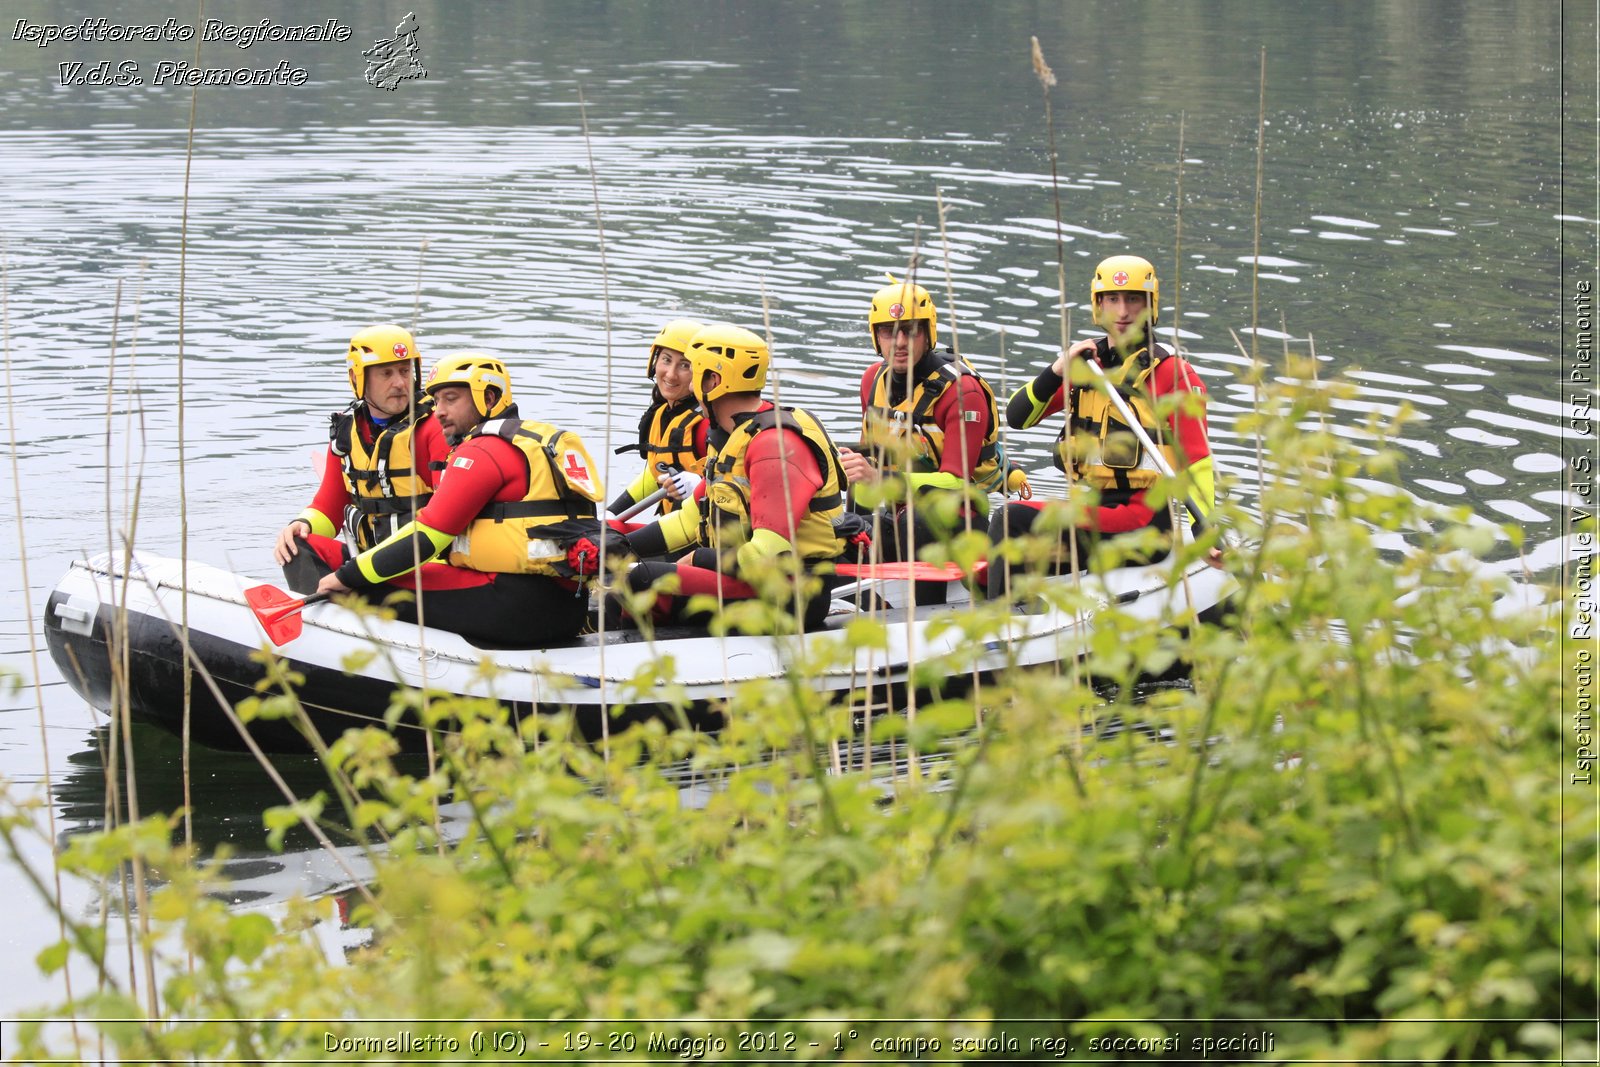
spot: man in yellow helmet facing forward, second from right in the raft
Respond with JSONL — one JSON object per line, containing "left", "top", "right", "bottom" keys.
{"left": 840, "top": 275, "right": 1006, "bottom": 603}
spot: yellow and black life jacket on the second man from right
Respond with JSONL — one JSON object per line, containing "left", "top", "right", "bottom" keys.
{"left": 861, "top": 350, "right": 1005, "bottom": 493}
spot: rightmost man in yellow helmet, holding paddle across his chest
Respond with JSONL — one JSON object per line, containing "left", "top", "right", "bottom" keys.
{"left": 989, "top": 256, "right": 1216, "bottom": 595}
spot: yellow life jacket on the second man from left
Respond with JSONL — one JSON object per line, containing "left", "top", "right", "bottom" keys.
{"left": 448, "top": 419, "right": 605, "bottom": 576}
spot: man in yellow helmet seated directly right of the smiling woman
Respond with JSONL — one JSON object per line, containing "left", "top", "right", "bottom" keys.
{"left": 627, "top": 323, "right": 845, "bottom": 629}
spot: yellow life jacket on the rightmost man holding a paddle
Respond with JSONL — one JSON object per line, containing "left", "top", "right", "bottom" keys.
{"left": 1054, "top": 346, "right": 1178, "bottom": 490}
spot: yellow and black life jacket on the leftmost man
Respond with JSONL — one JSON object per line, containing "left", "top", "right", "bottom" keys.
{"left": 328, "top": 395, "right": 434, "bottom": 552}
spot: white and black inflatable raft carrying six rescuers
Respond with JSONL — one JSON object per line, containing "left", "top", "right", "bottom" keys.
{"left": 45, "top": 553, "right": 1232, "bottom": 750}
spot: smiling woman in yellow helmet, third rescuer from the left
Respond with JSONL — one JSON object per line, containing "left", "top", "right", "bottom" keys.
{"left": 610, "top": 318, "right": 706, "bottom": 515}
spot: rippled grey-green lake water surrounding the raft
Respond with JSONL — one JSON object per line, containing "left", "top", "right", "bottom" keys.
{"left": 0, "top": 0, "right": 1597, "bottom": 1016}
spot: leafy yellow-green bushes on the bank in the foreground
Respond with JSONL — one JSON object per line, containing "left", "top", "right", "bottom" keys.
{"left": 5, "top": 379, "right": 1600, "bottom": 1062}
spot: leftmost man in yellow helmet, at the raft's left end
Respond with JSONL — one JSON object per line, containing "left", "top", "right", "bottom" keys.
{"left": 272, "top": 323, "right": 448, "bottom": 593}
